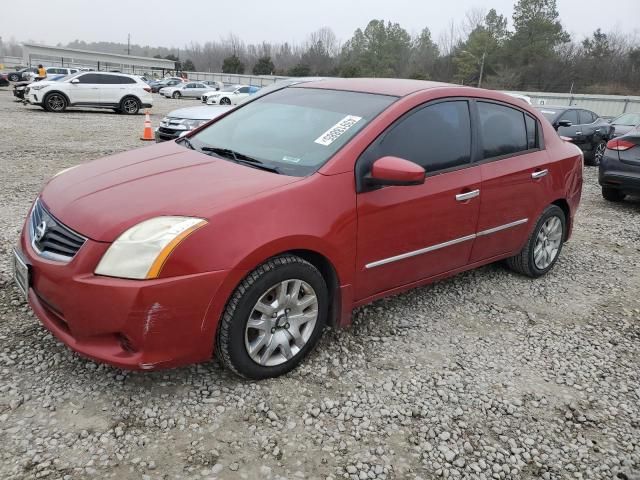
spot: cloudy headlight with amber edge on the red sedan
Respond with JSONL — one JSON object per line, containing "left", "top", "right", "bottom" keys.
{"left": 94, "top": 217, "right": 207, "bottom": 280}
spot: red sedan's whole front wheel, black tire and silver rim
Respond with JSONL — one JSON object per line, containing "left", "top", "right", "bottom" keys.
{"left": 216, "top": 255, "right": 329, "bottom": 380}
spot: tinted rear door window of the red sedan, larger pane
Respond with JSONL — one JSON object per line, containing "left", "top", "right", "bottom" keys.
{"left": 477, "top": 102, "right": 529, "bottom": 159}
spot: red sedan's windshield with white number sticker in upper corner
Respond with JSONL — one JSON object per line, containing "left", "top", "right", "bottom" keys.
{"left": 190, "top": 88, "right": 397, "bottom": 176}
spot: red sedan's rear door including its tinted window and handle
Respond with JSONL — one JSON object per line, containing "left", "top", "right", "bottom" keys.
{"left": 471, "top": 100, "right": 552, "bottom": 262}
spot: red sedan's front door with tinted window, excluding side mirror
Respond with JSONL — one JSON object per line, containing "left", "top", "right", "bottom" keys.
{"left": 355, "top": 100, "right": 481, "bottom": 300}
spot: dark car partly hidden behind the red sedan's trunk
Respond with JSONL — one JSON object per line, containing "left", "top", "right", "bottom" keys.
{"left": 536, "top": 105, "right": 613, "bottom": 165}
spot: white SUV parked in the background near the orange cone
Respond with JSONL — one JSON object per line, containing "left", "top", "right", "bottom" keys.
{"left": 25, "top": 72, "right": 153, "bottom": 115}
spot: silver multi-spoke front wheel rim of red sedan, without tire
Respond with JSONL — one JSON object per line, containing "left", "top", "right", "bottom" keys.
{"left": 245, "top": 279, "right": 318, "bottom": 367}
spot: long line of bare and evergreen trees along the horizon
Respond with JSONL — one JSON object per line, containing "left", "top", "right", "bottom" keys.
{"left": 5, "top": 0, "right": 640, "bottom": 94}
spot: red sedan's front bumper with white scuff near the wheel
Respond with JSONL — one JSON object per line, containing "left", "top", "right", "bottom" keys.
{"left": 19, "top": 222, "right": 229, "bottom": 370}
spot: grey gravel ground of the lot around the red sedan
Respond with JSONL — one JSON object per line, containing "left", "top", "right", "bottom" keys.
{"left": 0, "top": 89, "right": 640, "bottom": 480}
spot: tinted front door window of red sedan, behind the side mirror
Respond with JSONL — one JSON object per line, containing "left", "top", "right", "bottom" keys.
{"left": 375, "top": 100, "right": 471, "bottom": 174}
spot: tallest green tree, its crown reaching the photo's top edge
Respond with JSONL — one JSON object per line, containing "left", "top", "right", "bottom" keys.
{"left": 508, "top": 0, "right": 570, "bottom": 65}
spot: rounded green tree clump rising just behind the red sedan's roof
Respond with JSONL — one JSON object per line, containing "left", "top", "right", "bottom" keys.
{"left": 340, "top": 20, "right": 411, "bottom": 77}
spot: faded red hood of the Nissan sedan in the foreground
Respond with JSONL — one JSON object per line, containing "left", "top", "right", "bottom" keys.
{"left": 41, "top": 142, "right": 301, "bottom": 242}
